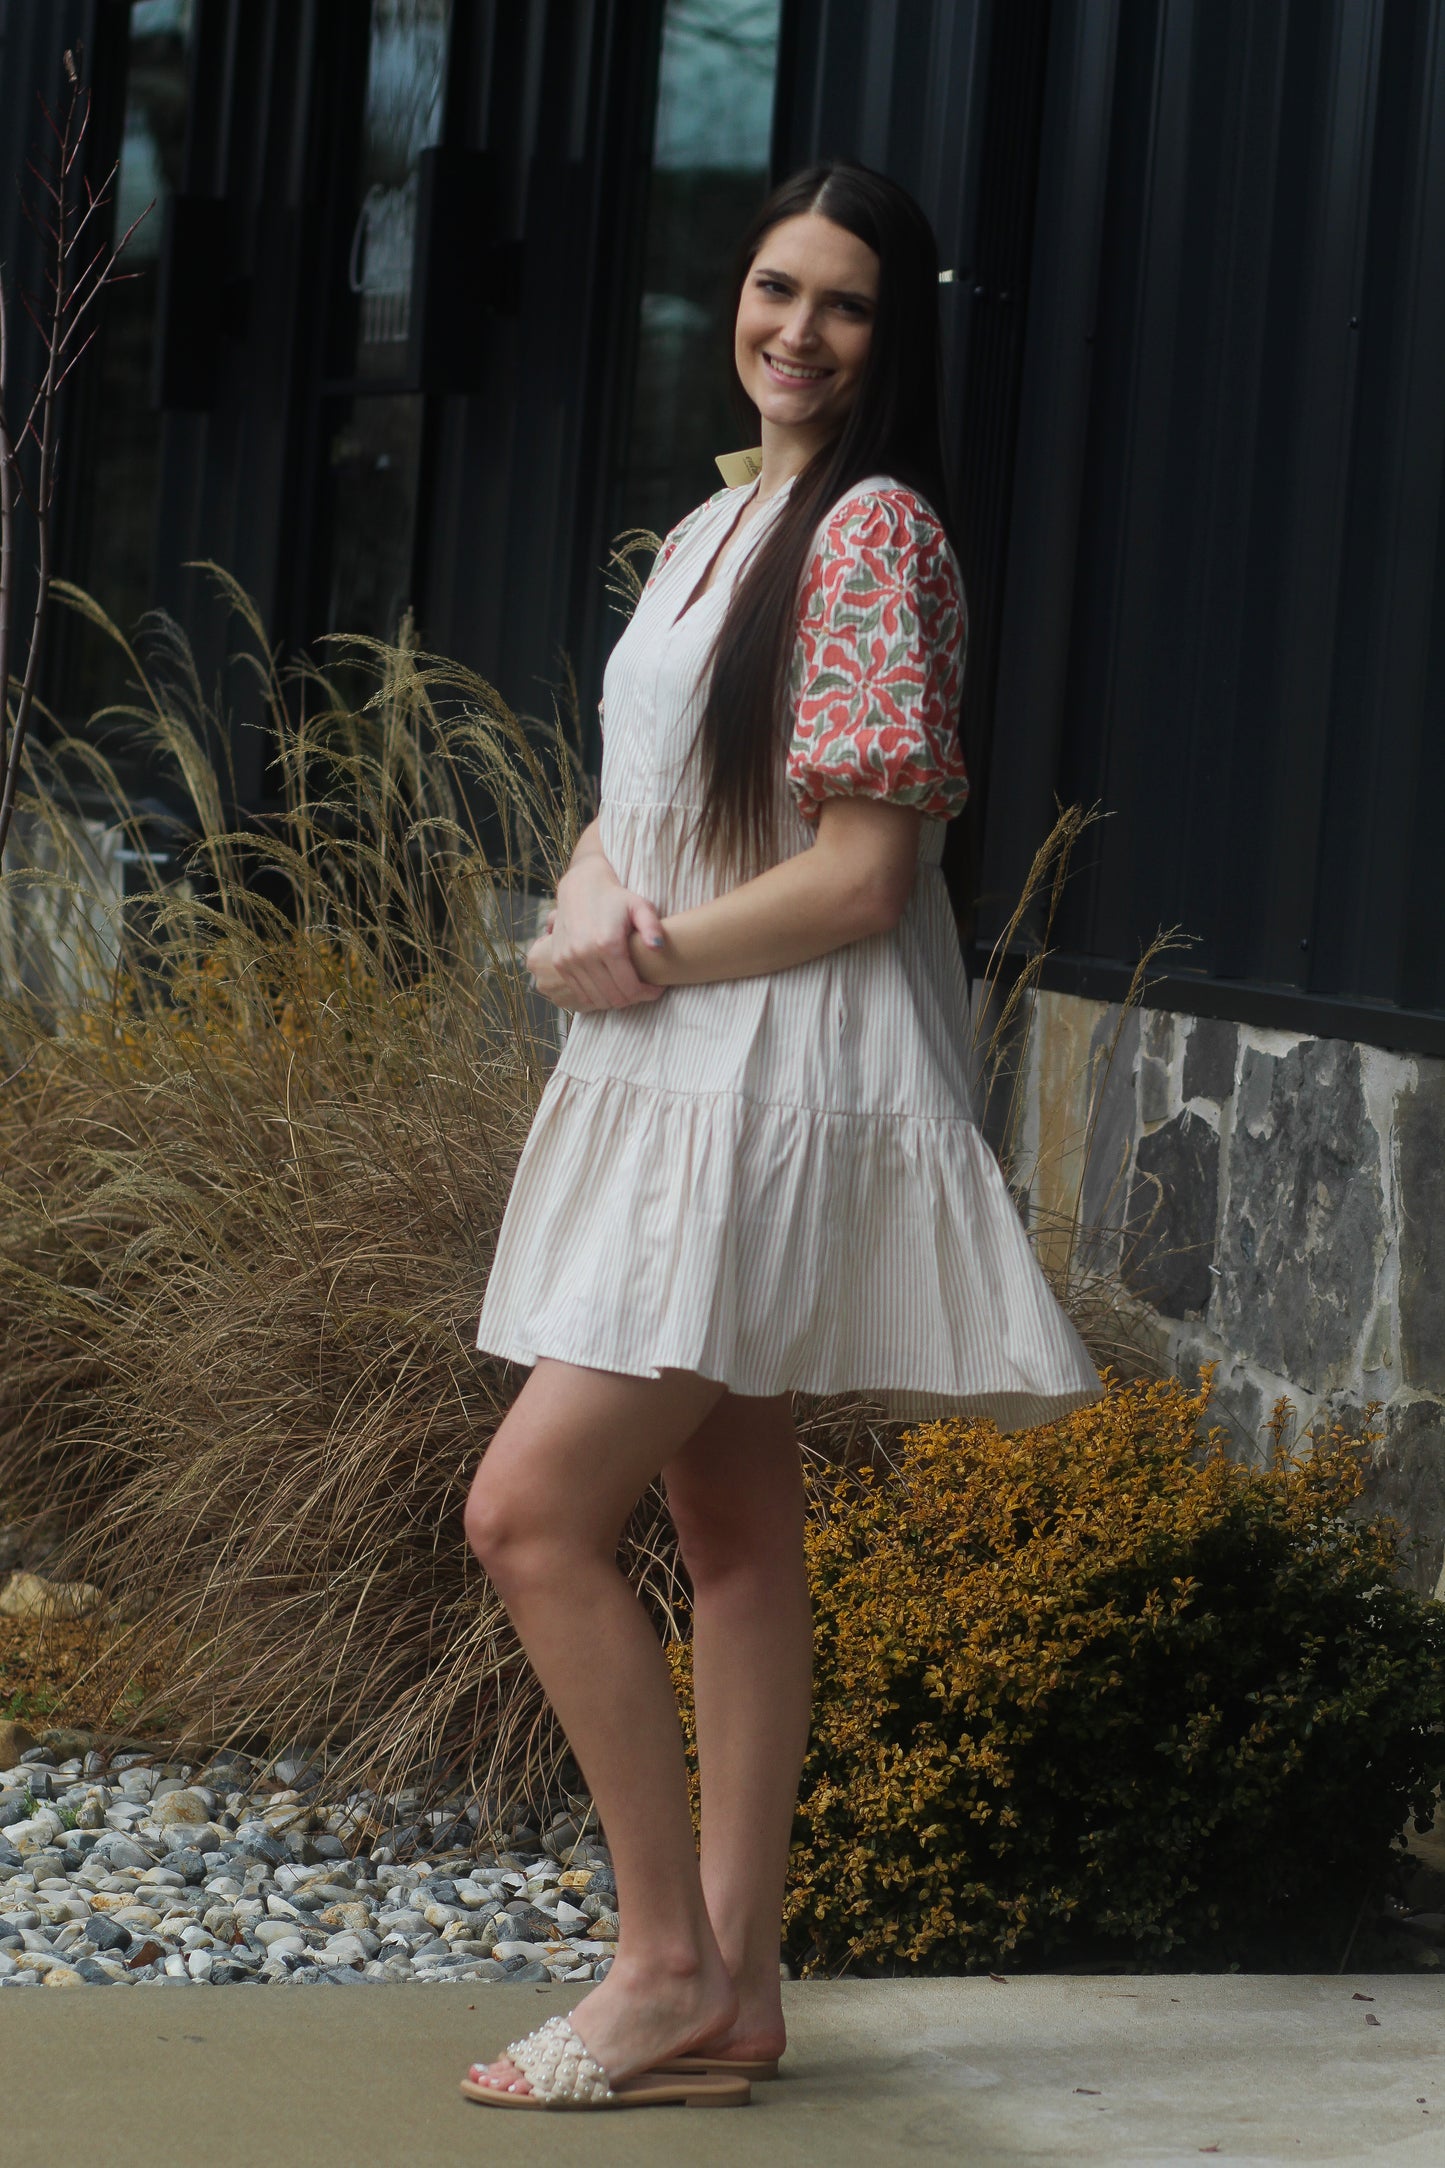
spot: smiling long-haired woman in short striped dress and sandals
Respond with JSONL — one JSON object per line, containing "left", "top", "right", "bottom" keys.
{"left": 466, "top": 165, "right": 1098, "bottom": 2107}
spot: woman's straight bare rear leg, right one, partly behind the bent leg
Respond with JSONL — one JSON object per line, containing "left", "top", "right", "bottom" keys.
{"left": 663, "top": 1392, "right": 812, "bottom": 2060}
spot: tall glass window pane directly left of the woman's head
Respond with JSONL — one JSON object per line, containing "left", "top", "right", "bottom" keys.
{"left": 620, "top": 0, "right": 780, "bottom": 533}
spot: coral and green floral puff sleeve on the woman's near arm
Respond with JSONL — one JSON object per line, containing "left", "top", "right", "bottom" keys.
{"left": 789, "top": 488, "right": 968, "bottom": 822}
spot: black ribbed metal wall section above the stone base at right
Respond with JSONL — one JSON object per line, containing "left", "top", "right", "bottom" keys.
{"left": 988, "top": 0, "right": 1445, "bottom": 1028}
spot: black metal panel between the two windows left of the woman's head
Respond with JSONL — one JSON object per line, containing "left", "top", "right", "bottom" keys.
{"left": 429, "top": 0, "right": 661, "bottom": 737}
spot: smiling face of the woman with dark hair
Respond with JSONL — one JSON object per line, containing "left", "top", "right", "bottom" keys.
{"left": 734, "top": 210, "right": 880, "bottom": 464}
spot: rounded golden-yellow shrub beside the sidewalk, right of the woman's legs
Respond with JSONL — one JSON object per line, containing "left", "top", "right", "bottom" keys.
{"left": 682, "top": 1381, "right": 1445, "bottom": 1971}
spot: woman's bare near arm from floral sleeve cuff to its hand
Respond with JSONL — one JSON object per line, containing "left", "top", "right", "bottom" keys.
{"left": 526, "top": 798, "right": 923, "bottom": 1008}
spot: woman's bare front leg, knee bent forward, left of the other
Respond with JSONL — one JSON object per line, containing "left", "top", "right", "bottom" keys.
{"left": 466, "top": 1362, "right": 737, "bottom": 2083}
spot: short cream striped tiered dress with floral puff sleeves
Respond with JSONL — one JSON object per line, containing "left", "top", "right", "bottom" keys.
{"left": 477, "top": 477, "right": 1098, "bottom": 1429}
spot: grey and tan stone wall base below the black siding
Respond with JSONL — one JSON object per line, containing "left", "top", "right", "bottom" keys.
{"left": 1005, "top": 993, "right": 1445, "bottom": 1596}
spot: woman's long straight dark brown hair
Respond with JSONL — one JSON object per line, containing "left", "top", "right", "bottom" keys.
{"left": 693, "top": 160, "right": 949, "bottom": 878}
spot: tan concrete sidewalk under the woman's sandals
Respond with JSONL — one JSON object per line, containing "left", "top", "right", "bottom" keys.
{"left": 0, "top": 1975, "right": 1445, "bottom": 2168}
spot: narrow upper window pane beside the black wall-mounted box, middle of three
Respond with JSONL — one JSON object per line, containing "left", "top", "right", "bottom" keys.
{"left": 347, "top": 0, "right": 451, "bottom": 377}
